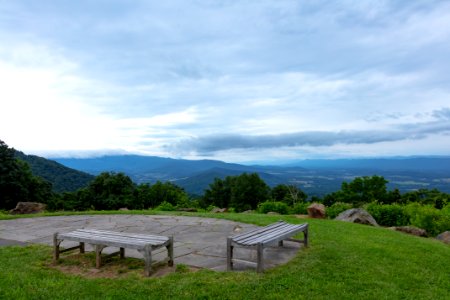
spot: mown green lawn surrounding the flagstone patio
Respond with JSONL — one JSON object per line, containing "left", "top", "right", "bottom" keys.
{"left": 0, "top": 211, "right": 450, "bottom": 299}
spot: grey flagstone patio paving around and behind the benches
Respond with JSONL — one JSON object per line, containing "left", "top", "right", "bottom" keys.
{"left": 0, "top": 215, "right": 301, "bottom": 271}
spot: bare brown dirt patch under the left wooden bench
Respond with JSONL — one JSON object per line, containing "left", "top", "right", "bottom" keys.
{"left": 48, "top": 253, "right": 199, "bottom": 278}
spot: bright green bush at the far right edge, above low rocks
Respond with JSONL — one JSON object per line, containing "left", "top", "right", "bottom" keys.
{"left": 405, "top": 203, "right": 450, "bottom": 236}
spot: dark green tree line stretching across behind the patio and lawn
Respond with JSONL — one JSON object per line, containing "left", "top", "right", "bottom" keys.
{"left": 0, "top": 140, "right": 450, "bottom": 213}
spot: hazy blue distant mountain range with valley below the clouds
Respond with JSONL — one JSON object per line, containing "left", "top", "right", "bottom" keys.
{"left": 55, "top": 155, "right": 450, "bottom": 196}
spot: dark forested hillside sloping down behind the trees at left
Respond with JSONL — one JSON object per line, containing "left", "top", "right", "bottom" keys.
{"left": 16, "top": 151, "right": 94, "bottom": 193}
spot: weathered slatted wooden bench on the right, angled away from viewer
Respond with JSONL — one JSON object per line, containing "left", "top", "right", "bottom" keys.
{"left": 227, "top": 221, "right": 308, "bottom": 272}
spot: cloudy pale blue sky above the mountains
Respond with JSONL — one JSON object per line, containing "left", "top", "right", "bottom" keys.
{"left": 0, "top": 0, "right": 450, "bottom": 162}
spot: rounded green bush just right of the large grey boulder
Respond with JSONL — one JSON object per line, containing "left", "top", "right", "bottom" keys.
{"left": 365, "top": 202, "right": 409, "bottom": 227}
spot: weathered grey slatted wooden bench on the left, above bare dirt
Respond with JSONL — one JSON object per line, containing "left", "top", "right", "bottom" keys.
{"left": 53, "top": 229, "right": 173, "bottom": 276}
